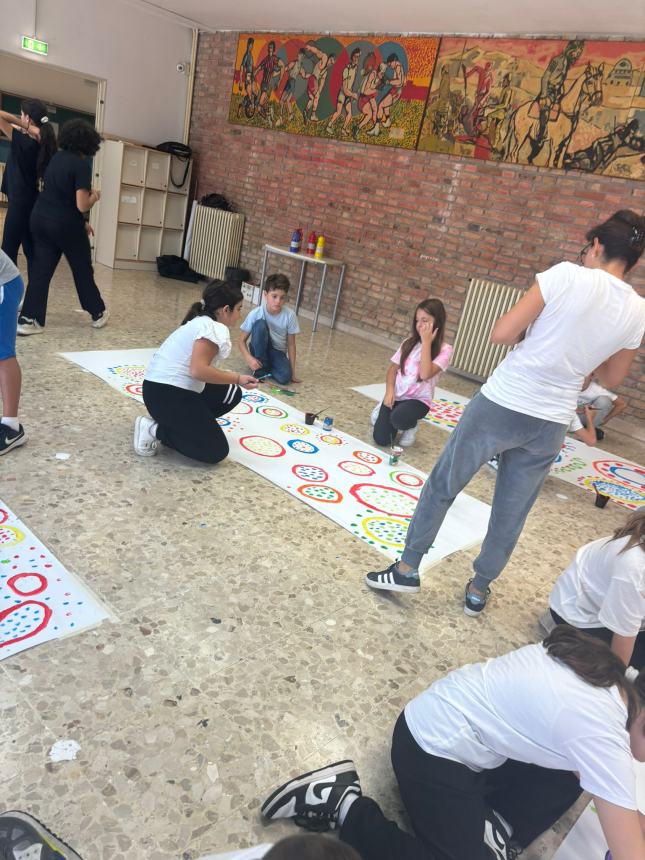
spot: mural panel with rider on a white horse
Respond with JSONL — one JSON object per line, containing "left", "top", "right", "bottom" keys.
{"left": 419, "top": 37, "right": 645, "bottom": 180}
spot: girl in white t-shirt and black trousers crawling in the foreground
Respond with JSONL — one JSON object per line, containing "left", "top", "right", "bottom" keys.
{"left": 262, "top": 626, "right": 645, "bottom": 860}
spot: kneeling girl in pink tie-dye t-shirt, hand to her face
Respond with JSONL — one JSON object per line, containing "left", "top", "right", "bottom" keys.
{"left": 372, "top": 299, "right": 452, "bottom": 448}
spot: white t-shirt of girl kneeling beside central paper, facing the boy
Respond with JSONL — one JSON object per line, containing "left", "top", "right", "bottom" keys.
{"left": 143, "top": 316, "right": 231, "bottom": 394}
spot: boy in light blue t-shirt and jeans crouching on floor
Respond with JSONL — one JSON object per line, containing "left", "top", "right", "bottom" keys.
{"left": 240, "top": 275, "right": 300, "bottom": 385}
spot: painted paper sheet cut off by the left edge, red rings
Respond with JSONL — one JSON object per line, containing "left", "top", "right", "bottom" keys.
{"left": 0, "top": 501, "right": 114, "bottom": 660}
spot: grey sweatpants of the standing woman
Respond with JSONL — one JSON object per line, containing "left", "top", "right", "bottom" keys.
{"left": 401, "top": 394, "right": 567, "bottom": 591}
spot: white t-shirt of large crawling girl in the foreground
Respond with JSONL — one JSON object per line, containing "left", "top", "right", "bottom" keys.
{"left": 405, "top": 644, "right": 637, "bottom": 809}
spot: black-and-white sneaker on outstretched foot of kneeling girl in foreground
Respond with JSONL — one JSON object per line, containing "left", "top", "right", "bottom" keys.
{"left": 261, "top": 760, "right": 361, "bottom": 833}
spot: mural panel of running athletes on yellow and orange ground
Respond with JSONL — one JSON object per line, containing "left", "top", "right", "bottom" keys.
{"left": 229, "top": 33, "right": 439, "bottom": 149}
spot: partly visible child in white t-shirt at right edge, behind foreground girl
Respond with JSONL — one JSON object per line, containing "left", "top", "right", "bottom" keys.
{"left": 549, "top": 509, "right": 645, "bottom": 672}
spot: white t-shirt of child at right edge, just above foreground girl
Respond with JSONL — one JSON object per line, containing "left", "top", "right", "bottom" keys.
{"left": 549, "top": 536, "right": 645, "bottom": 636}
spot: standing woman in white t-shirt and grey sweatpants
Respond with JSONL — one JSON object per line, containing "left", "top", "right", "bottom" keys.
{"left": 366, "top": 210, "right": 645, "bottom": 617}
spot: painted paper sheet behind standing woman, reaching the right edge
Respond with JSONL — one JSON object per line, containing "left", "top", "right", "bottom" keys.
{"left": 352, "top": 383, "right": 645, "bottom": 510}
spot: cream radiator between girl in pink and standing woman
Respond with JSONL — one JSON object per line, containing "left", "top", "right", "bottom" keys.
{"left": 450, "top": 278, "right": 524, "bottom": 381}
